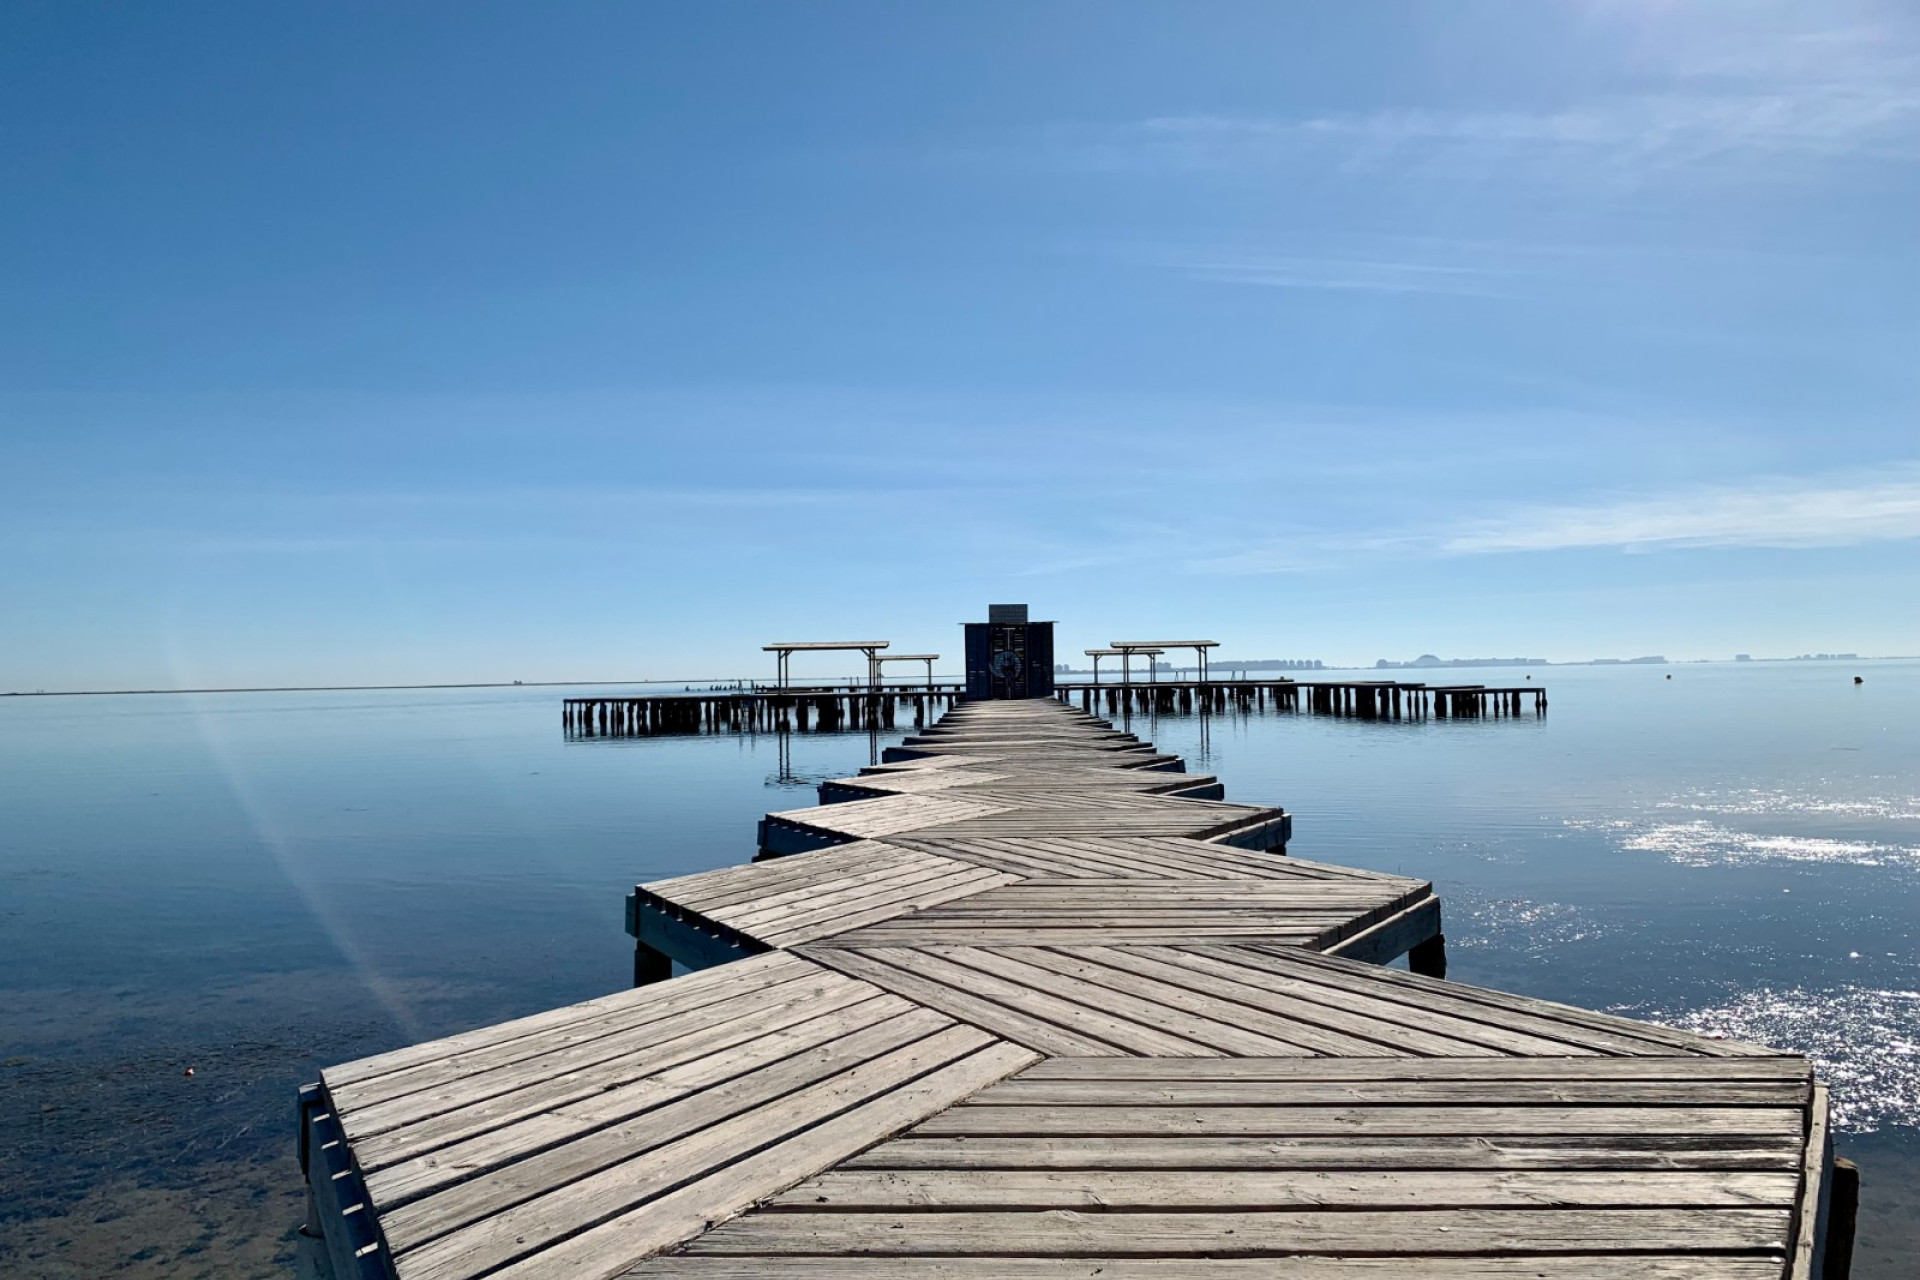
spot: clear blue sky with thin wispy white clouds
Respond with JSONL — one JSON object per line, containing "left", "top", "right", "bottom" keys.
{"left": 0, "top": 0, "right": 1920, "bottom": 689}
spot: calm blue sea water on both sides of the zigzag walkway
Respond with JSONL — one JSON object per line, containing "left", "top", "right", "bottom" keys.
{"left": 0, "top": 662, "right": 1920, "bottom": 1276}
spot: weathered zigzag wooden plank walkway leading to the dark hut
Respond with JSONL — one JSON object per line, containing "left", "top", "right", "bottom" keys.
{"left": 301, "top": 700, "right": 1849, "bottom": 1280}
